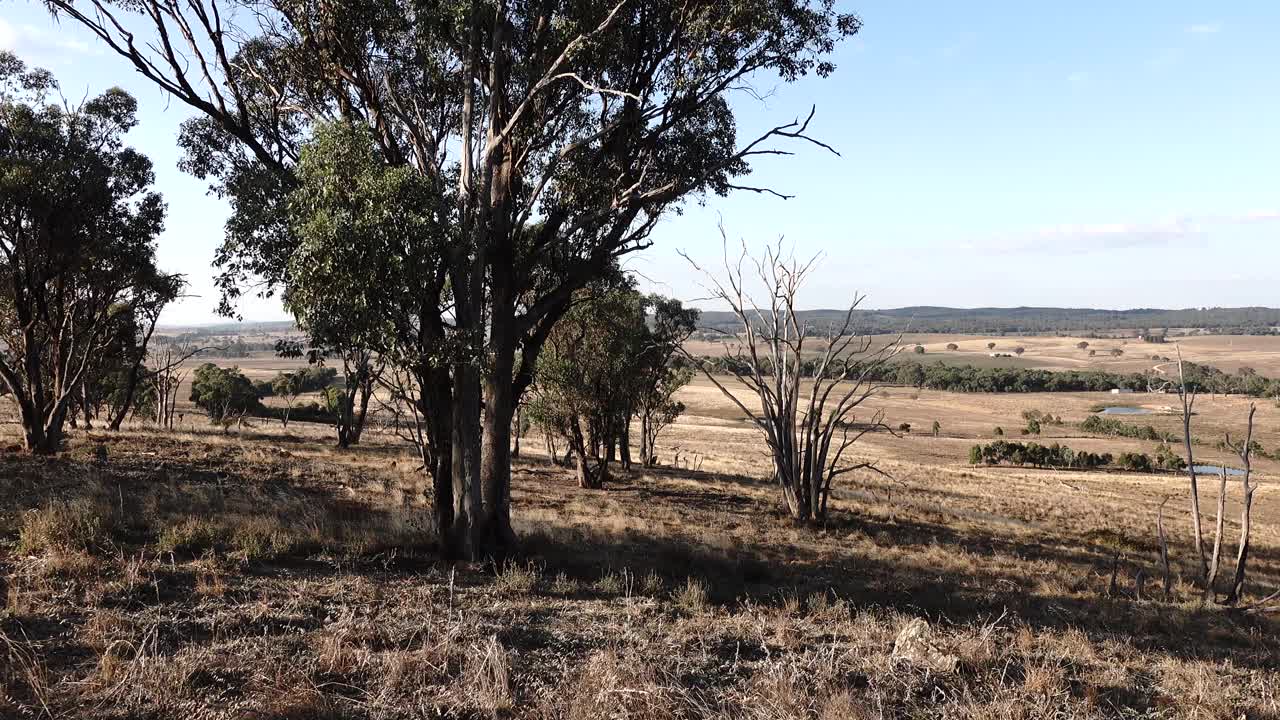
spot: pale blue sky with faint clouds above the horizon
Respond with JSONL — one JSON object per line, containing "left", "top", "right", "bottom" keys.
{"left": 0, "top": 0, "right": 1280, "bottom": 324}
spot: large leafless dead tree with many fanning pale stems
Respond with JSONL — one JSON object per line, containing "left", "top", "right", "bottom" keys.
{"left": 685, "top": 234, "right": 900, "bottom": 523}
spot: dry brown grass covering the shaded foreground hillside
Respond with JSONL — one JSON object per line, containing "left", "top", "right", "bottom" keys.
{"left": 0, "top": 397, "right": 1280, "bottom": 720}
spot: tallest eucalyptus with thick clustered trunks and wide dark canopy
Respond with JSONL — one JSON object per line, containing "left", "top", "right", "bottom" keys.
{"left": 49, "top": 0, "right": 859, "bottom": 556}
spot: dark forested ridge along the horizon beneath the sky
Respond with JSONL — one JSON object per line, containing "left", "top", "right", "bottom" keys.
{"left": 699, "top": 306, "right": 1280, "bottom": 336}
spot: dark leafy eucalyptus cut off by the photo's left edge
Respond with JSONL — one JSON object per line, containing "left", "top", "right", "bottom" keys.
{"left": 0, "top": 53, "right": 180, "bottom": 454}
